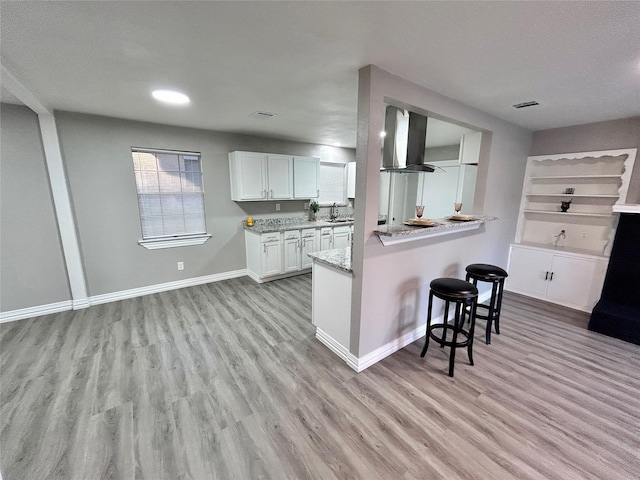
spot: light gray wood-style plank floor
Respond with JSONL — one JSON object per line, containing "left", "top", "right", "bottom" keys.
{"left": 0, "top": 275, "right": 640, "bottom": 480}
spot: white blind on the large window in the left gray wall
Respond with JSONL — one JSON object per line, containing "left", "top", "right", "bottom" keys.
{"left": 131, "top": 148, "right": 206, "bottom": 240}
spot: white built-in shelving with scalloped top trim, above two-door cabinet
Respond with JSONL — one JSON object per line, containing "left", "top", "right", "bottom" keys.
{"left": 516, "top": 149, "right": 636, "bottom": 256}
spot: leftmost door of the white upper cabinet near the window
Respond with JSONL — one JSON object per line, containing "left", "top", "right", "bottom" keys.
{"left": 230, "top": 152, "right": 267, "bottom": 200}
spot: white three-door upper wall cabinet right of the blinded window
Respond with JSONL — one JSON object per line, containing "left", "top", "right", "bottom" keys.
{"left": 229, "top": 152, "right": 320, "bottom": 201}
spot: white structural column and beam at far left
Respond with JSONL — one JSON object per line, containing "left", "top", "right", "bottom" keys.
{"left": 0, "top": 65, "right": 90, "bottom": 310}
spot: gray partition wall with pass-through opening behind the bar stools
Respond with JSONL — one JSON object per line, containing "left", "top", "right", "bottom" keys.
{"left": 350, "top": 66, "right": 531, "bottom": 357}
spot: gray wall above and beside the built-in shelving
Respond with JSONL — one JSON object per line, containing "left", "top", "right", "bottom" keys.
{"left": 531, "top": 117, "right": 640, "bottom": 204}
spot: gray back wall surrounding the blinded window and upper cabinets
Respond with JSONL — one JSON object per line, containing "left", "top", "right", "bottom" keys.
{"left": 56, "top": 112, "right": 354, "bottom": 296}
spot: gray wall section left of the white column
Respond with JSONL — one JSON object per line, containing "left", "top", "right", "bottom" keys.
{"left": 0, "top": 104, "right": 71, "bottom": 312}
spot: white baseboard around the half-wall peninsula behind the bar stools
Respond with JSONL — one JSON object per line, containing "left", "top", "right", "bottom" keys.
{"left": 316, "top": 292, "right": 491, "bottom": 372}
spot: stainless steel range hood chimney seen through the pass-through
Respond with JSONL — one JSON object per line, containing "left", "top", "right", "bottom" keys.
{"left": 380, "top": 105, "right": 435, "bottom": 173}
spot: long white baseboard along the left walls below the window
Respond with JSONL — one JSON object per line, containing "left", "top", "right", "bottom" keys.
{"left": 0, "top": 269, "right": 247, "bottom": 323}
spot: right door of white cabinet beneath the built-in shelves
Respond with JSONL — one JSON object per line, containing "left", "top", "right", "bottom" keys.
{"left": 547, "top": 255, "right": 599, "bottom": 309}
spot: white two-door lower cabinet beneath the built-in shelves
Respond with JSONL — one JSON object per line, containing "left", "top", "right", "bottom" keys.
{"left": 505, "top": 245, "right": 608, "bottom": 312}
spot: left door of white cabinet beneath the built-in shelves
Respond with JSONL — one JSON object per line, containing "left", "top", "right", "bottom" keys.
{"left": 506, "top": 247, "right": 553, "bottom": 296}
